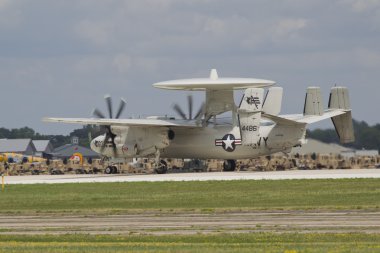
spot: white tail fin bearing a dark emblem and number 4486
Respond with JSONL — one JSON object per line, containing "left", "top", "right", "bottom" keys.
{"left": 238, "top": 88, "right": 264, "bottom": 146}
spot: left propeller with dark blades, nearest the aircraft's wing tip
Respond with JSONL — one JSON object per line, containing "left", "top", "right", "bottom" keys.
{"left": 92, "top": 95, "right": 126, "bottom": 155}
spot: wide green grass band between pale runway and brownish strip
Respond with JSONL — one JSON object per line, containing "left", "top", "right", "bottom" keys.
{"left": 0, "top": 179, "right": 380, "bottom": 214}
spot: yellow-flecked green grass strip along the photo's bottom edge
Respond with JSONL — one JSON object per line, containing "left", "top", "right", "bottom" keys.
{"left": 0, "top": 233, "right": 380, "bottom": 253}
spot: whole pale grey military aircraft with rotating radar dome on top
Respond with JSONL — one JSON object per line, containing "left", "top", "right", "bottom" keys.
{"left": 44, "top": 69, "right": 354, "bottom": 173}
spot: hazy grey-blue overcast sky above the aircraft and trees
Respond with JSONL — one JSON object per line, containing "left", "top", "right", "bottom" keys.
{"left": 0, "top": 0, "right": 380, "bottom": 134}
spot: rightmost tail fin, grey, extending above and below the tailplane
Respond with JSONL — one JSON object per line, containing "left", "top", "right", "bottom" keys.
{"left": 329, "top": 87, "right": 355, "bottom": 143}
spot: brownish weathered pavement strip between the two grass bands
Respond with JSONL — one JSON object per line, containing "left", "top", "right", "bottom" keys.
{"left": 0, "top": 211, "right": 380, "bottom": 235}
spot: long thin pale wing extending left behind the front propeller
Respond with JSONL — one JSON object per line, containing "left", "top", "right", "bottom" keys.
{"left": 43, "top": 118, "right": 202, "bottom": 128}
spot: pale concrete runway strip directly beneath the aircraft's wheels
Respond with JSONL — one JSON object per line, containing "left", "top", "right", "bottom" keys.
{"left": 5, "top": 169, "right": 380, "bottom": 184}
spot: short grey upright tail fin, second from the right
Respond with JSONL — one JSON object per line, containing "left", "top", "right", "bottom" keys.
{"left": 303, "top": 87, "right": 323, "bottom": 116}
